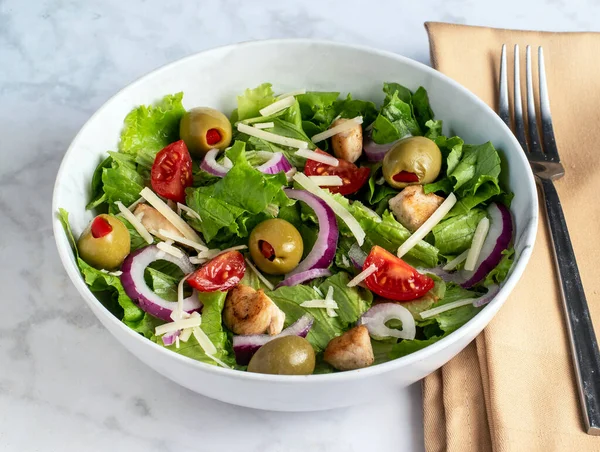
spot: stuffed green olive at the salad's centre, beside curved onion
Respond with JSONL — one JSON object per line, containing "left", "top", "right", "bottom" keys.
{"left": 248, "top": 218, "right": 304, "bottom": 275}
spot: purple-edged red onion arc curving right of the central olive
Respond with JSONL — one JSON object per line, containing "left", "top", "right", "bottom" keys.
{"left": 284, "top": 188, "right": 339, "bottom": 279}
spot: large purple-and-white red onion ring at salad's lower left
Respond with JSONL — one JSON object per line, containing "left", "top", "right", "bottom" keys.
{"left": 121, "top": 245, "right": 202, "bottom": 322}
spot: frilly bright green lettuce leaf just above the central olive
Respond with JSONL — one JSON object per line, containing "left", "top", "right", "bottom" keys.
{"left": 187, "top": 142, "right": 293, "bottom": 243}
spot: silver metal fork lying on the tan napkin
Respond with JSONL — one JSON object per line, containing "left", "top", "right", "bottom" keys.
{"left": 498, "top": 45, "right": 600, "bottom": 435}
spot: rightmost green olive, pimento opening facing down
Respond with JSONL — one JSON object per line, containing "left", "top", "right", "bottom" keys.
{"left": 383, "top": 137, "right": 442, "bottom": 188}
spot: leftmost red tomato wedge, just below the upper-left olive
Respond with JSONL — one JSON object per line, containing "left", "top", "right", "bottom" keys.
{"left": 150, "top": 140, "right": 193, "bottom": 203}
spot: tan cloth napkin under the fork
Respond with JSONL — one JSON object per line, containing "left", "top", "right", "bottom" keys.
{"left": 423, "top": 23, "right": 600, "bottom": 452}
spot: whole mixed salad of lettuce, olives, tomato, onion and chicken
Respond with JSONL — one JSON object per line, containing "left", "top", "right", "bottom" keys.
{"left": 59, "top": 82, "right": 514, "bottom": 375}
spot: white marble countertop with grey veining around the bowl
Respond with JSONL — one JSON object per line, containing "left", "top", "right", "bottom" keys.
{"left": 0, "top": 0, "right": 600, "bottom": 452}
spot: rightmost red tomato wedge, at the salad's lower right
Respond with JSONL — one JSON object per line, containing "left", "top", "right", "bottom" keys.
{"left": 363, "top": 246, "right": 434, "bottom": 301}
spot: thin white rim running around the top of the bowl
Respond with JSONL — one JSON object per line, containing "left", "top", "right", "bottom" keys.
{"left": 52, "top": 38, "right": 538, "bottom": 384}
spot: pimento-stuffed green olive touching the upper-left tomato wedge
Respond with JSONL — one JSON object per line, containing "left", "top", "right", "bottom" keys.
{"left": 179, "top": 107, "right": 231, "bottom": 157}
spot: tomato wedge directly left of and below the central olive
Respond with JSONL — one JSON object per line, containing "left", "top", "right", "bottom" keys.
{"left": 187, "top": 251, "right": 246, "bottom": 292}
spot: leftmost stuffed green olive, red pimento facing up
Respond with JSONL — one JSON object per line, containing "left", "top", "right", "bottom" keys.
{"left": 77, "top": 214, "right": 130, "bottom": 270}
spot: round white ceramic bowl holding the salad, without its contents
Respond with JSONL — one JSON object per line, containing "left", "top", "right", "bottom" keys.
{"left": 53, "top": 40, "right": 538, "bottom": 411}
